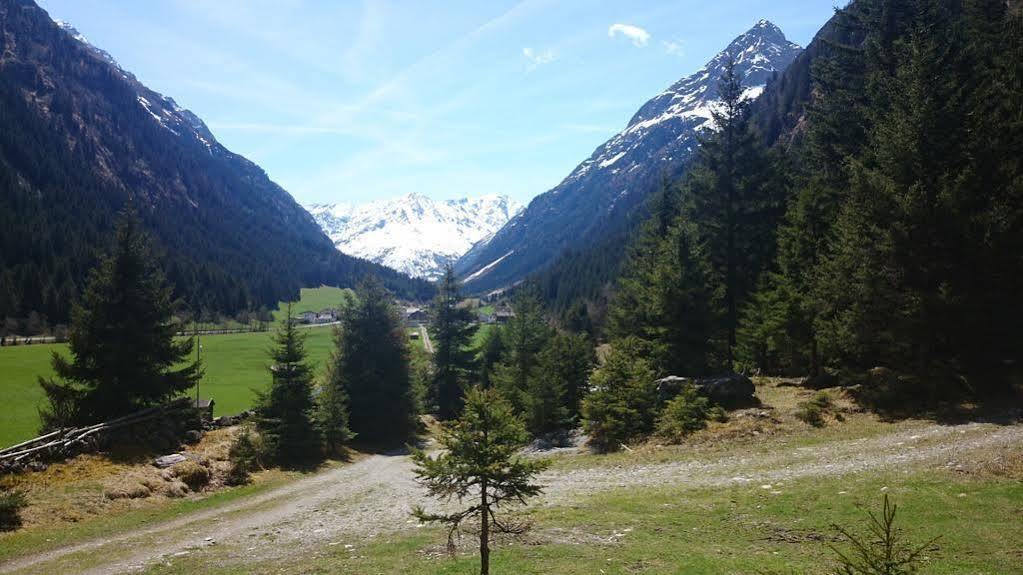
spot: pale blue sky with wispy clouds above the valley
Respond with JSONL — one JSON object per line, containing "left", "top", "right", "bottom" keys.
{"left": 40, "top": 0, "right": 835, "bottom": 204}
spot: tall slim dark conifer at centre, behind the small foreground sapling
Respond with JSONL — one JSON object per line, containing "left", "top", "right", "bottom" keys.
{"left": 430, "top": 266, "right": 476, "bottom": 419}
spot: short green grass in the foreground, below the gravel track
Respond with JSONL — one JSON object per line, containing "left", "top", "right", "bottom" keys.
{"left": 146, "top": 452, "right": 1023, "bottom": 575}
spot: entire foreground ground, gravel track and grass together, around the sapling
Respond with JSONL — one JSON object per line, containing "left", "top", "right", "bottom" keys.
{"left": 0, "top": 384, "right": 1023, "bottom": 574}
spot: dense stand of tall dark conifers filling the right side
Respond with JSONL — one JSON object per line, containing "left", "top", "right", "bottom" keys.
{"left": 576, "top": 0, "right": 1023, "bottom": 407}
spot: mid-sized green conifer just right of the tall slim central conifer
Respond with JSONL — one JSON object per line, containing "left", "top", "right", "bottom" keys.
{"left": 494, "top": 290, "right": 550, "bottom": 413}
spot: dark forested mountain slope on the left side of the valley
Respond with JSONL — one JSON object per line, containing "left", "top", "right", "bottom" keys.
{"left": 0, "top": 0, "right": 431, "bottom": 322}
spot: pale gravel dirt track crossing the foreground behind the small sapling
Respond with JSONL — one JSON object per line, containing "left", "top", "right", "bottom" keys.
{"left": 0, "top": 424, "right": 1023, "bottom": 574}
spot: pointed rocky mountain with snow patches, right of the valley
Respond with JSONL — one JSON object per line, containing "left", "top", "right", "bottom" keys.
{"left": 455, "top": 20, "right": 801, "bottom": 292}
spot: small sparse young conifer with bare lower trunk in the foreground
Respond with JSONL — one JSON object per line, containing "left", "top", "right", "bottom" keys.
{"left": 412, "top": 388, "right": 546, "bottom": 575}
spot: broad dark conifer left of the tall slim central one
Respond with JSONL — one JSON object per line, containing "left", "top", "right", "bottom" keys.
{"left": 328, "top": 277, "right": 418, "bottom": 446}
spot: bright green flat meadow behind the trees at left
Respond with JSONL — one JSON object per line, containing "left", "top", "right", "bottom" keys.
{"left": 0, "top": 288, "right": 356, "bottom": 446}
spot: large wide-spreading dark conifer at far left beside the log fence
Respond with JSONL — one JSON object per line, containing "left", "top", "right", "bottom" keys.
{"left": 39, "top": 211, "right": 202, "bottom": 429}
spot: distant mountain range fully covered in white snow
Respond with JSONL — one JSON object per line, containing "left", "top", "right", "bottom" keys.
{"left": 307, "top": 192, "right": 522, "bottom": 279}
